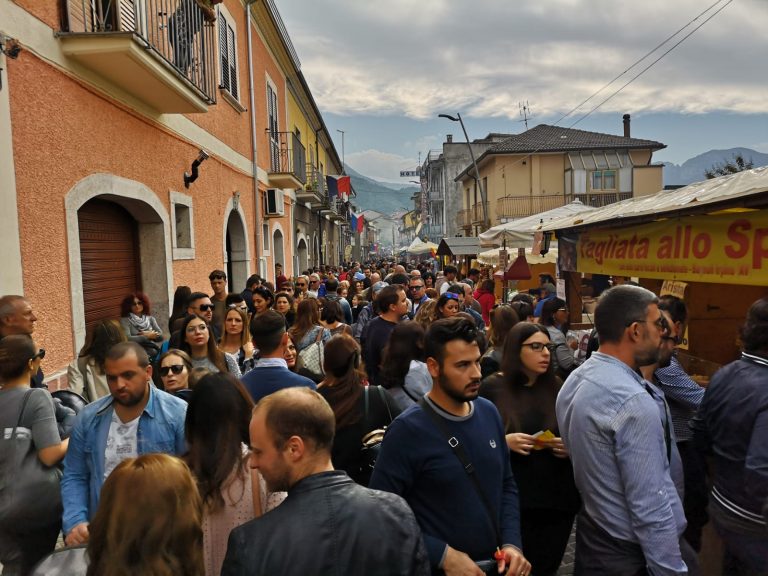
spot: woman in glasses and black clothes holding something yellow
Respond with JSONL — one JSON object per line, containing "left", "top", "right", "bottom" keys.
{"left": 480, "top": 322, "right": 580, "bottom": 576}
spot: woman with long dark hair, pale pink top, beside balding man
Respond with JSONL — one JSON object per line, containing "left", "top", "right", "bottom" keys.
{"left": 184, "top": 373, "right": 282, "bottom": 576}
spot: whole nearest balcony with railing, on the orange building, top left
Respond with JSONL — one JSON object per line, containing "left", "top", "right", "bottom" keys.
{"left": 58, "top": 0, "right": 217, "bottom": 113}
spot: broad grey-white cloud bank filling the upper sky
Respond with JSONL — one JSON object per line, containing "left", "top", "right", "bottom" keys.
{"left": 280, "top": 0, "right": 768, "bottom": 119}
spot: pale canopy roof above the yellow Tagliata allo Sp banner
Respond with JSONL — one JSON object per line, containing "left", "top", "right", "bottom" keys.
{"left": 536, "top": 166, "right": 768, "bottom": 232}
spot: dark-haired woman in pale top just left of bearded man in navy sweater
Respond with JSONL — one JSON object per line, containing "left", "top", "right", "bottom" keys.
{"left": 381, "top": 322, "right": 432, "bottom": 410}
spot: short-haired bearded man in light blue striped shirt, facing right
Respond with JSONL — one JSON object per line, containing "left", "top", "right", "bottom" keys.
{"left": 556, "top": 285, "right": 689, "bottom": 576}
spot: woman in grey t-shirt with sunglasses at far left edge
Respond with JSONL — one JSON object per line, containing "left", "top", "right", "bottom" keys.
{"left": 0, "top": 335, "right": 69, "bottom": 574}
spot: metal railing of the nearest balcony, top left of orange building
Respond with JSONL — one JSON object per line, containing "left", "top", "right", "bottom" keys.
{"left": 67, "top": 0, "right": 216, "bottom": 104}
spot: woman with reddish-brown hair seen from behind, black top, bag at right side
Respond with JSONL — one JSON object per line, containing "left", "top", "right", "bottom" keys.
{"left": 317, "top": 334, "right": 400, "bottom": 486}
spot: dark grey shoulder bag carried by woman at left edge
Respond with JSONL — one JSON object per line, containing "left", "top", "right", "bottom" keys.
{"left": 0, "top": 389, "right": 62, "bottom": 529}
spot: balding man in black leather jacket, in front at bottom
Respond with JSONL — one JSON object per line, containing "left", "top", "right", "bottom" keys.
{"left": 221, "top": 388, "right": 430, "bottom": 576}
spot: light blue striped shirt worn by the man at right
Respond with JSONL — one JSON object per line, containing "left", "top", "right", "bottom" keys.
{"left": 556, "top": 352, "right": 687, "bottom": 575}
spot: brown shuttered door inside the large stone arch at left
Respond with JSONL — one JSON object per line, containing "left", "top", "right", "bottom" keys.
{"left": 77, "top": 199, "right": 142, "bottom": 330}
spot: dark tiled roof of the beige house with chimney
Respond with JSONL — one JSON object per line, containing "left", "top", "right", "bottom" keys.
{"left": 486, "top": 124, "right": 666, "bottom": 154}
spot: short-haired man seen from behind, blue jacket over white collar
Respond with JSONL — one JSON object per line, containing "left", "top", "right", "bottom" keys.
{"left": 241, "top": 310, "right": 317, "bottom": 403}
